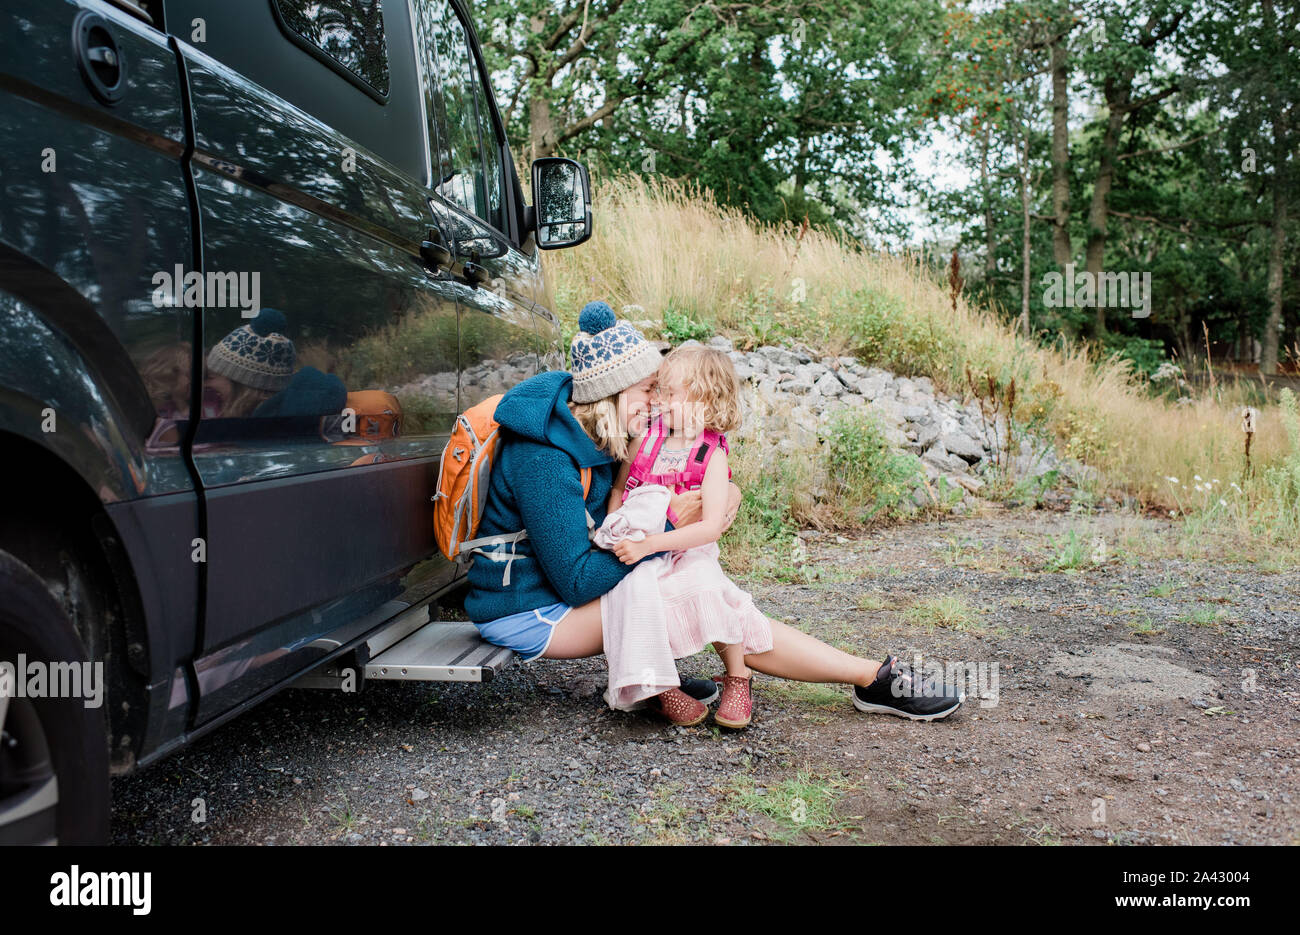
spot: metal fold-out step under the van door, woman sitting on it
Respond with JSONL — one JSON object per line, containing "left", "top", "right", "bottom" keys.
{"left": 365, "top": 623, "right": 515, "bottom": 681}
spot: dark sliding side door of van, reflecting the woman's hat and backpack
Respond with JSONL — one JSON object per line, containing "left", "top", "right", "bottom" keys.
{"left": 165, "top": 0, "right": 460, "bottom": 723}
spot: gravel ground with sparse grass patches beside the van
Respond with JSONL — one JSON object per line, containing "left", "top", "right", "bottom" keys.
{"left": 113, "top": 506, "right": 1300, "bottom": 844}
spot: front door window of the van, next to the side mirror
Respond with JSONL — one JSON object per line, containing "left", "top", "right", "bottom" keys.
{"left": 416, "top": 0, "right": 504, "bottom": 230}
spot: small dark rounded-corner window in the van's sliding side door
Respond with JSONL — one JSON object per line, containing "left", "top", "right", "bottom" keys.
{"left": 273, "top": 0, "right": 389, "bottom": 96}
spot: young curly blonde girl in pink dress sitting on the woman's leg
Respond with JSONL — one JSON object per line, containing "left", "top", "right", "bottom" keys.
{"left": 610, "top": 345, "right": 772, "bottom": 728}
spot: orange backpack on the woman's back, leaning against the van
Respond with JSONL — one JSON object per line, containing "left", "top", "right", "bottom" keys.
{"left": 432, "top": 393, "right": 595, "bottom": 588}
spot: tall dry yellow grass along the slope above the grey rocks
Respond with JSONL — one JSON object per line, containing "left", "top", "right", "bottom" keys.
{"left": 545, "top": 176, "right": 1294, "bottom": 551}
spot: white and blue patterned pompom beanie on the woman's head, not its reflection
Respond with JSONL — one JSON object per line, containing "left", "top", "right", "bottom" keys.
{"left": 569, "top": 302, "right": 663, "bottom": 403}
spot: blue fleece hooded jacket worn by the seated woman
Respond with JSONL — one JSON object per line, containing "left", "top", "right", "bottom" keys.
{"left": 465, "top": 371, "right": 672, "bottom": 623}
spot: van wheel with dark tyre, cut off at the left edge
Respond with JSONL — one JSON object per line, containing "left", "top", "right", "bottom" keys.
{"left": 0, "top": 551, "right": 111, "bottom": 844}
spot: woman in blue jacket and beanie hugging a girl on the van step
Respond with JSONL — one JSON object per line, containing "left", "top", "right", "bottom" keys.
{"left": 465, "top": 310, "right": 965, "bottom": 723}
